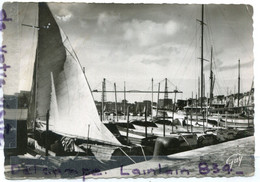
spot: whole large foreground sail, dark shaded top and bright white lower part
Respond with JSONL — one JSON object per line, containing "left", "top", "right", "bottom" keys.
{"left": 29, "top": 3, "right": 121, "bottom": 146}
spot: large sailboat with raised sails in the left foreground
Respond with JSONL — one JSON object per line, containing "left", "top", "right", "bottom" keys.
{"left": 28, "top": 3, "right": 129, "bottom": 160}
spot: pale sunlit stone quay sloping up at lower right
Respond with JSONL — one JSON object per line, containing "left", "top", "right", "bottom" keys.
{"left": 99, "top": 136, "right": 255, "bottom": 178}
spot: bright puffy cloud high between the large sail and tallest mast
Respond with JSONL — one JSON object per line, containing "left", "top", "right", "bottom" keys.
{"left": 123, "top": 19, "right": 178, "bottom": 47}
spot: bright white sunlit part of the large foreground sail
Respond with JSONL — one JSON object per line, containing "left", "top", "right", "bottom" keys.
{"left": 50, "top": 43, "right": 121, "bottom": 145}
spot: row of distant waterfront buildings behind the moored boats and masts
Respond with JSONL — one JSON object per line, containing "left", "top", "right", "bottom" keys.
{"left": 95, "top": 89, "right": 254, "bottom": 115}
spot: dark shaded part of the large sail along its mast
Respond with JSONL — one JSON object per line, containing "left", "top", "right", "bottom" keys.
{"left": 33, "top": 3, "right": 66, "bottom": 120}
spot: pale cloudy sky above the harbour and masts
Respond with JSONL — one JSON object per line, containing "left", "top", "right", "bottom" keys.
{"left": 4, "top": 3, "right": 254, "bottom": 101}
